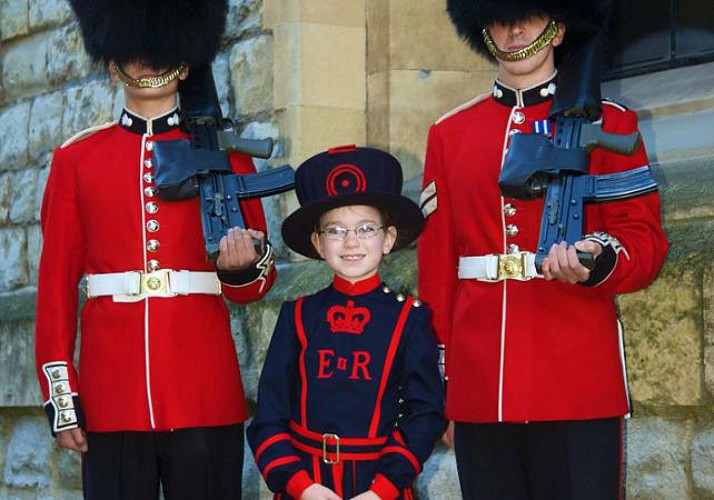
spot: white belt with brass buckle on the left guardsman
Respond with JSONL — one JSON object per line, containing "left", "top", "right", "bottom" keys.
{"left": 86, "top": 269, "right": 221, "bottom": 302}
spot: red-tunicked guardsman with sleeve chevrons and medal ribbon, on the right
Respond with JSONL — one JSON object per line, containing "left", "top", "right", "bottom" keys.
{"left": 418, "top": 0, "right": 668, "bottom": 500}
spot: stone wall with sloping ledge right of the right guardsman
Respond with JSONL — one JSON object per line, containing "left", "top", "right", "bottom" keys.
{"left": 604, "top": 64, "right": 714, "bottom": 499}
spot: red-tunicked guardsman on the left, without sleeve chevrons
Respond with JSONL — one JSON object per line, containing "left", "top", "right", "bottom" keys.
{"left": 36, "top": 0, "right": 276, "bottom": 500}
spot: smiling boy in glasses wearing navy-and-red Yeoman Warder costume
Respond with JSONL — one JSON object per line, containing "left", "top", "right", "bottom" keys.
{"left": 247, "top": 146, "right": 444, "bottom": 500}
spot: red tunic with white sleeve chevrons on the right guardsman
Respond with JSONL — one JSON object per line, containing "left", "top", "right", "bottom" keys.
{"left": 418, "top": 77, "right": 668, "bottom": 422}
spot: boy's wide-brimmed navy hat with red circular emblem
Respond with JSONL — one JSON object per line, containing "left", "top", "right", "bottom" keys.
{"left": 282, "top": 145, "right": 424, "bottom": 259}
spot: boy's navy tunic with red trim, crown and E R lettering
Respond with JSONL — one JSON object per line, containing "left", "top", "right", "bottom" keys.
{"left": 248, "top": 275, "right": 444, "bottom": 499}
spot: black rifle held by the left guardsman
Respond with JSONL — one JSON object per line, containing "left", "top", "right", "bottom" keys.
{"left": 153, "top": 64, "right": 295, "bottom": 261}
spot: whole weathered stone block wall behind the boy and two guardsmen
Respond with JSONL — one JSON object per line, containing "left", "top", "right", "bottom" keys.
{"left": 0, "top": 0, "right": 714, "bottom": 499}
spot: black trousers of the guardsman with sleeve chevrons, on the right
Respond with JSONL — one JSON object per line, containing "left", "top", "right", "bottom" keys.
{"left": 454, "top": 418, "right": 623, "bottom": 500}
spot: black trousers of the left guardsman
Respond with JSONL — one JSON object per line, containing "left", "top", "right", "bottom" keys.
{"left": 82, "top": 424, "right": 244, "bottom": 500}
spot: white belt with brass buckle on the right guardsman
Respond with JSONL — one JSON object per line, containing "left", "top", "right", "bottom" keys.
{"left": 459, "top": 252, "right": 542, "bottom": 281}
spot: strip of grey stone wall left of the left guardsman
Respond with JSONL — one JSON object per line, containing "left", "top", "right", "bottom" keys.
{"left": 0, "top": 1, "right": 85, "bottom": 498}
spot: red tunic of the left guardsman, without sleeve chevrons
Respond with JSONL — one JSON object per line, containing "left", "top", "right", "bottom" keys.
{"left": 36, "top": 112, "right": 276, "bottom": 432}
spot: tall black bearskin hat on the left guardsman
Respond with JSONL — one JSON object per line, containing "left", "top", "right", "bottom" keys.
{"left": 69, "top": 0, "right": 228, "bottom": 68}
